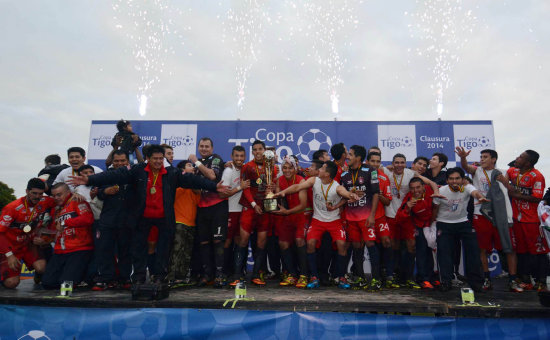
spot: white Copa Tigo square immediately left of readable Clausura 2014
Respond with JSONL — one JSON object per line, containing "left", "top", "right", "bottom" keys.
{"left": 378, "top": 125, "right": 416, "bottom": 161}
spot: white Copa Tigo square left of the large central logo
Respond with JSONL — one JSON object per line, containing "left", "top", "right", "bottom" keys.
{"left": 160, "top": 124, "right": 198, "bottom": 159}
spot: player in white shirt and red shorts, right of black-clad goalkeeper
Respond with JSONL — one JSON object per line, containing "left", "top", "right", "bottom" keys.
{"left": 222, "top": 145, "right": 250, "bottom": 274}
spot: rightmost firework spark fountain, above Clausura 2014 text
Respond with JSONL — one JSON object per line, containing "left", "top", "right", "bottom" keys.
{"left": 405, "top": 0, "right": 477, "bottom": 119}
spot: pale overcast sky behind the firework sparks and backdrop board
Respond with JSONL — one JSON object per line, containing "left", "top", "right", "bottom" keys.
{"left": 0, "top": 0, "right": 550, "bottom": 196}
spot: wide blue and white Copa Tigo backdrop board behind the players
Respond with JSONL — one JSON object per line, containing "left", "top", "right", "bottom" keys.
{"left": 88, "top": 121, "right": 495, "bottom": 167}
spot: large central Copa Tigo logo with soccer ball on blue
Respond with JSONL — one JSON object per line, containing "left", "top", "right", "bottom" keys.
{"left": 227, "top": 128, "right": 332, "bottom": 162}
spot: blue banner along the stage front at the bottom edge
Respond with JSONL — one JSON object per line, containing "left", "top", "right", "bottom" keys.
{"left": 0, "top": 305, "right": 550, "bottom": 340}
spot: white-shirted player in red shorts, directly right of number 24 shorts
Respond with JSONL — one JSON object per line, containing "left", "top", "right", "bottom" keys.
{"left": 384, "top": 153, "right": 439, "bottom": 289}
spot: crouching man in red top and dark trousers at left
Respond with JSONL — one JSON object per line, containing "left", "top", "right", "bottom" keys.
{"left": 42, "top": 183, "right": 94, "bottom": 289}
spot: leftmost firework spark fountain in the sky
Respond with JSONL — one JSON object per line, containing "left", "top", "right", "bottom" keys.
{"left": 113, "top": 0, "right": 182, "bottom": 116}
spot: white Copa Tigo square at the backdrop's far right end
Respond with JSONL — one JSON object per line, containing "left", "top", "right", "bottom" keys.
{"left": 453, "top": 125, "right": 495, "bottom": 162}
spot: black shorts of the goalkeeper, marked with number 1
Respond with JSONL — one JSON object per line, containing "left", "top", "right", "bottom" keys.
{"left": 197, "top": 200, "right": 229, "bottom": 243}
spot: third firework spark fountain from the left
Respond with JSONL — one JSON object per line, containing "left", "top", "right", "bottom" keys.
{"left": 287, "top": 0, "right": 362, "bottom": 114}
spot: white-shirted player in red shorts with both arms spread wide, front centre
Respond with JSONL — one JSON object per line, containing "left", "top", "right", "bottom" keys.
{"left": 276, "top": 161, "right": 359, "bottom": 289}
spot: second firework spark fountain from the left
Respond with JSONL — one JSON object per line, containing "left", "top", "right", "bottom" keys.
{"left": 223, "top": 0, "right": 271, "bottom": 110}
